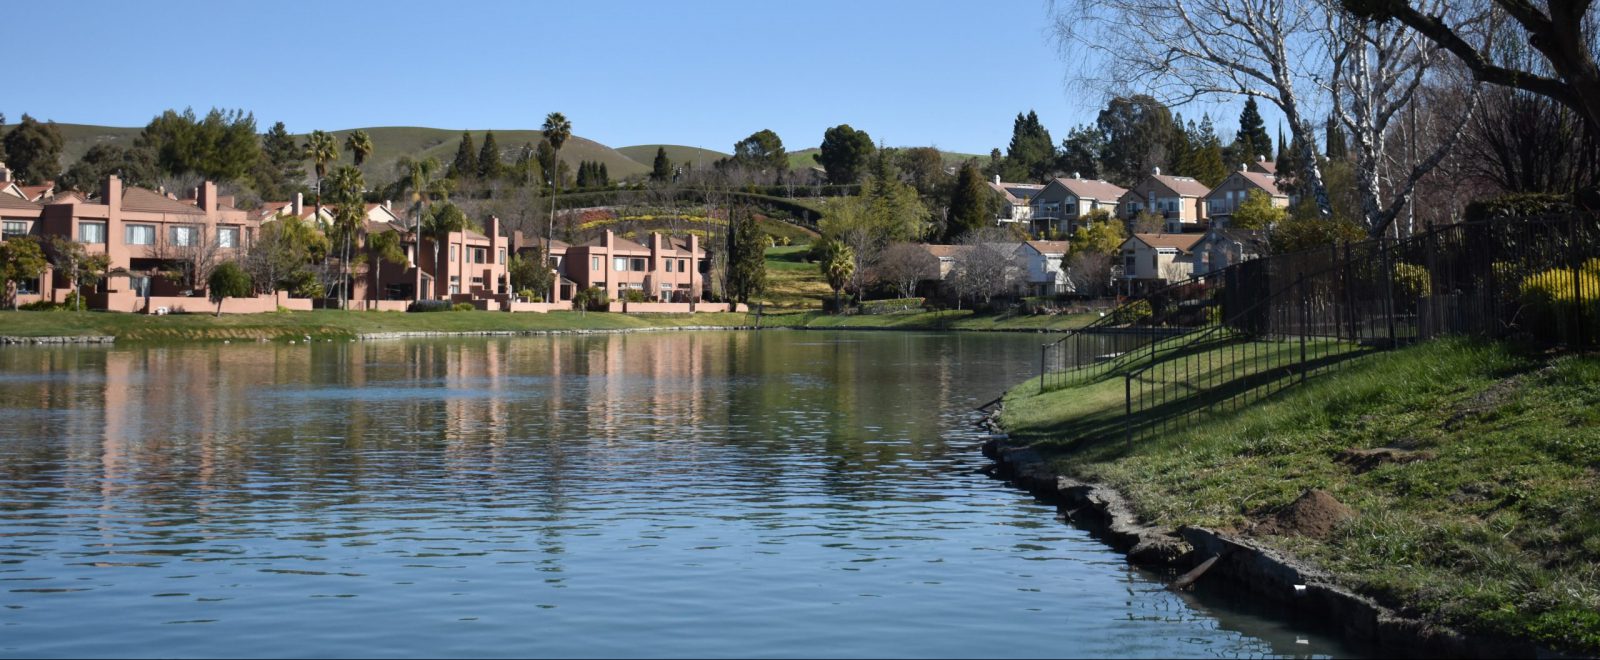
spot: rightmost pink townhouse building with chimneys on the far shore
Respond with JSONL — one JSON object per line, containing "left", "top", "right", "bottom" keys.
{"left": 565, "top": 231, "right": 706, "bottom": 303}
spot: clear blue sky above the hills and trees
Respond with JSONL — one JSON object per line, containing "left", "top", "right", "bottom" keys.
{"left": 0, "top": 0, "right": 1272, "bottom": 154}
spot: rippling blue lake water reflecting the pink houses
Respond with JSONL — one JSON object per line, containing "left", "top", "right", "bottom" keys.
{"left": 0, "top": 332, "right": 1349, "bottom": 657}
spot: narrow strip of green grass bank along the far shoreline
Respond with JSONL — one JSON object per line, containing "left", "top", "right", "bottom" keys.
{"left": 0, "top": 309, "right": 1088, "bottom": 343}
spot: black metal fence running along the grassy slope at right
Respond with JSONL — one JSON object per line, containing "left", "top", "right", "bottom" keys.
{"left": 1040, "top": 215, "right": 1600, "bottom": 442}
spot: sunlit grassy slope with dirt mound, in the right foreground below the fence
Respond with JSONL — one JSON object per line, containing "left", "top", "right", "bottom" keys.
{"left": 1003, "top": 340, "right": 1600, "bottom": 655}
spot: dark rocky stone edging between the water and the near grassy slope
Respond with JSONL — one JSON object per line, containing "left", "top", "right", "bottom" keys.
{"left": 982, "top": 410, "right": 1562, "bottom": 658}
